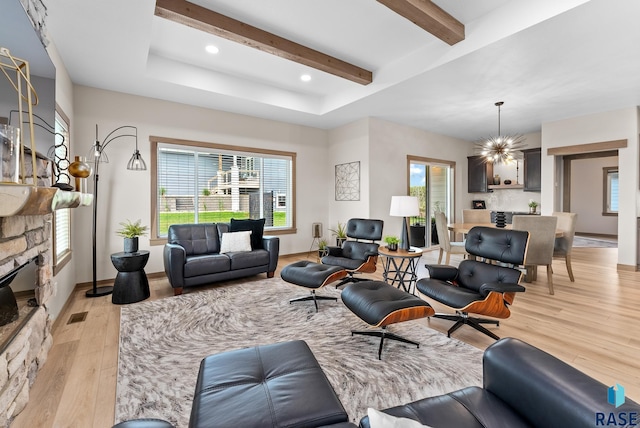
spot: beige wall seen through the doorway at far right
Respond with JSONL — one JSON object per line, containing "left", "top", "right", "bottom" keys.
{"left": 570, "top": 156, "right": 618, "bottom": 235}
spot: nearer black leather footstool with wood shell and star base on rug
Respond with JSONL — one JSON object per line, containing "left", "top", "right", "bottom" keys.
{"left": 340, "top": 281, "right": 435, "bottom": 360}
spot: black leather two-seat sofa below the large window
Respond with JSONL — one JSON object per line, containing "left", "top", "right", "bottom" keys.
{"left": 164, "top": 223, "right": 280, "bottom": 295}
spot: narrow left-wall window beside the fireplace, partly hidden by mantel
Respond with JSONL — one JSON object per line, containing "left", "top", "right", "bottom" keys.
{"left": 53, "top": 109, "right": 71, "bottom": 275}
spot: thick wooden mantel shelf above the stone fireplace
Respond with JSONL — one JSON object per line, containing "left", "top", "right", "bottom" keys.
{"left": 0, "top": 184, "right": 93, "bottom": 217}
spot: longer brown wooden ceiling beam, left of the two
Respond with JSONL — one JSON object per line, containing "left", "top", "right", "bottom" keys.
{"left": 155, "top": 0, "right": 373, "bottom": 85}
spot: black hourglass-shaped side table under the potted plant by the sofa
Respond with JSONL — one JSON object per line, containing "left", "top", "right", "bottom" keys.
{"left": 111, "top": 250, "right": 151, "bottom": 305}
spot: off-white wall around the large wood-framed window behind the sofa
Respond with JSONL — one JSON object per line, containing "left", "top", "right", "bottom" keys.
{"left": 73, "top": 86, "right": 330, "bottom": 282}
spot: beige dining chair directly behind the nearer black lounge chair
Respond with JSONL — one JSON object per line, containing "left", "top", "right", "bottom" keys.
{"left": 512, "top": 215, "right": 558, "bottom": 294}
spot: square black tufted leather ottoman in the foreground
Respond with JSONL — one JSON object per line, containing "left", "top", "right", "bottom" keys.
{"left": 189, "top": 340, "right": 355, "bottom": 428}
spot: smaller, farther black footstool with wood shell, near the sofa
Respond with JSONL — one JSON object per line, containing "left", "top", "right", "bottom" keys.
{"left": 280, "top": 260, "right": 347, "bottom": 312}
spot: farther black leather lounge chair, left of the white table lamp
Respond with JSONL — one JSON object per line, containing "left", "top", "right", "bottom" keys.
{"left": 322, "top": 218, "right": 384, "bottom": 288}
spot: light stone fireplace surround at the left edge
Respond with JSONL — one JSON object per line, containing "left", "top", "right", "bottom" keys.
{"left": 0, "top": 150, "right": 63, "bottom": 426}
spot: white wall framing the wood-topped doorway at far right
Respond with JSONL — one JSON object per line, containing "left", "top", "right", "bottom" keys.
{"left": 541, "top": 107, "right": 639, "bottom": 267}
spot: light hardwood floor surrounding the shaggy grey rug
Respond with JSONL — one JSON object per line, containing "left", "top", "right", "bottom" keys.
{"left": 11, "top": 248, "right": 640, "bottom": 428}
